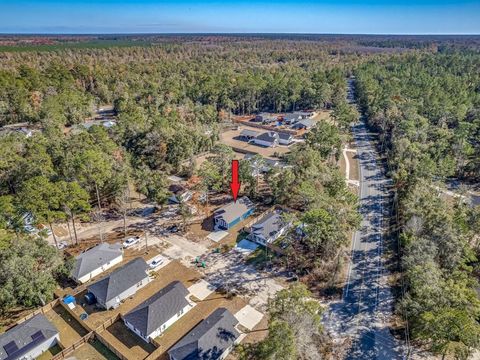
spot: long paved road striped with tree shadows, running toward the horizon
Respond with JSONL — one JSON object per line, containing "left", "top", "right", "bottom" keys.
{"left": 324, "top": 116, "right": 404, "bottom": 360}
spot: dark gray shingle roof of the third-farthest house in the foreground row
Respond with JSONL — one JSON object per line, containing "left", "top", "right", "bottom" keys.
{"left": 123, "top": 281, "right": 189, "bottom": 336}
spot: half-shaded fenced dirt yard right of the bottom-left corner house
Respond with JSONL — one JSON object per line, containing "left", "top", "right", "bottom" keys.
{"left": 45, "top": 305, "right": 88, "bottom": 348}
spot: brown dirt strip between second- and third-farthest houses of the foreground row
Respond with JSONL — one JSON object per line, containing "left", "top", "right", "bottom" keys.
{"left": 74, "top": 260, "right": 201, "bottom": 329}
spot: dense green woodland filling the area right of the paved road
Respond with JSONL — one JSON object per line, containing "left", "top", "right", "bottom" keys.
{"left": 356, "top": 53, "right": 480, "bottom": 359}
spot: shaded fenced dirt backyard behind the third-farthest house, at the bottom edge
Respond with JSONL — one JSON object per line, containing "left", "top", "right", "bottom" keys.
{"left": 106, "top": 320, "right": 156, "bottom": 359}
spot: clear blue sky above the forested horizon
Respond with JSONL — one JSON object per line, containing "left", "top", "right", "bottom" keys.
{"left": 0, "top": 0, "right": 480, "bottom": 34}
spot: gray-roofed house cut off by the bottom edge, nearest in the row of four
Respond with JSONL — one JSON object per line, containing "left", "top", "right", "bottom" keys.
{"left": 168, "top": 308, "right": 240, "bottom": 360}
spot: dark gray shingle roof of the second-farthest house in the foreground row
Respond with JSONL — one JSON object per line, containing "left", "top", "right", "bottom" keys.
{"left": 88, "top": 258, "right": 148, "bottom": 303}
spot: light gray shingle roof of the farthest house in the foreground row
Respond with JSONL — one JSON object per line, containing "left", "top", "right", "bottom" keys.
{"left": 72, "top": 243, "right": 123, "bottom": 279}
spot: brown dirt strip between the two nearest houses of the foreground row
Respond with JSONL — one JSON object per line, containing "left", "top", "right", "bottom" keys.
{"left": 151, "top": 293, "right": 246, "bottom": 359}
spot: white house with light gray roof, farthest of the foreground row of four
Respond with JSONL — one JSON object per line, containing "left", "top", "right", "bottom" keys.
{"left": 71, "top": 243, "right": 123, "bottom": 284}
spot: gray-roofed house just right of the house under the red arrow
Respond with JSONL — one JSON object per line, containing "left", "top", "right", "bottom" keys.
{"left": 247, "top": 210, "right": 291, "bottom": 246}
